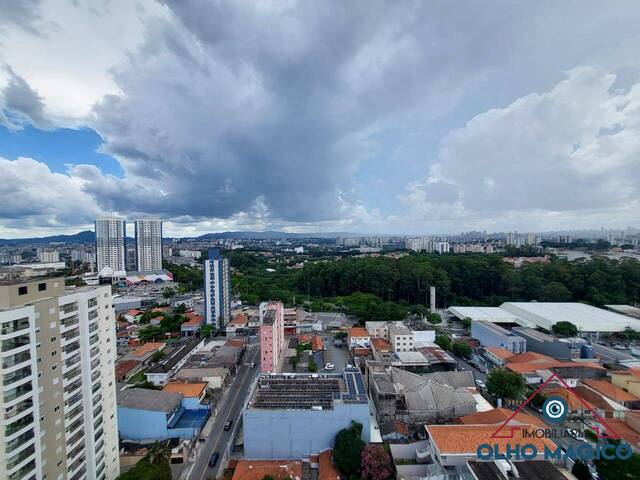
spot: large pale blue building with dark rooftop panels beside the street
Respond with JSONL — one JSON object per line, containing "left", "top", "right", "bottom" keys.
{"left": 242, "top": 369, "right": 370, "bottom": 460}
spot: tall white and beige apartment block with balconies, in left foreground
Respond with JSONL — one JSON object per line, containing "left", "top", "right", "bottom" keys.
{"left": 0, "top": 277, "right": 119, "bottom": 480}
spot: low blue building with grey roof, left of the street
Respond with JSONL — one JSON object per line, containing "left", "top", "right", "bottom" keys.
{"left": 117, "top": 388, "right": 211, "bottom": 442}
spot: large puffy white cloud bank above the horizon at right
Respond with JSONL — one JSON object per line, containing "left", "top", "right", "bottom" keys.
{"left": 402, "top": 67, "right": 640, "bottom": 228}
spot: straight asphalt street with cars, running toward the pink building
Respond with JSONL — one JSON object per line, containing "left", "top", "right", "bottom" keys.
{"left": 187, "top": 344, "right": 260, "bottom": 480}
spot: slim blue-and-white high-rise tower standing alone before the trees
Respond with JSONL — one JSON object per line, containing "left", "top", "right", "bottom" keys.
{"left": 204, "top": 249, "right": 231, "bottom": 331}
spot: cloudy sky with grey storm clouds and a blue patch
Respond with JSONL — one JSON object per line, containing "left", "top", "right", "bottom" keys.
{"left": 0, "top": 0, "right": 640, "bottom": 237}
